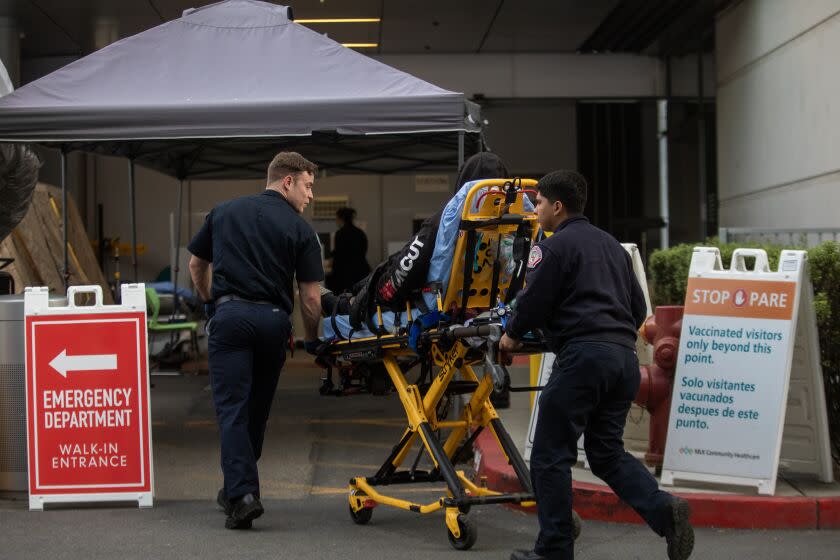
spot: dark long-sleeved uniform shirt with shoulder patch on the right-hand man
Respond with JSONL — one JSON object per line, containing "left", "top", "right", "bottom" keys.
{"left": 506, "top": 216, "right": 647, "bottom": 353}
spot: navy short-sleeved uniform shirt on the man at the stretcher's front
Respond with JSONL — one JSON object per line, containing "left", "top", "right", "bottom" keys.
{"left": 187, "top": 190, "right": 324, "bottom": 315}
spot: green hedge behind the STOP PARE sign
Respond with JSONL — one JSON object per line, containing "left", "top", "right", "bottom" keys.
{"left": 648, "top": 239, "right": 840, "bottom": 461}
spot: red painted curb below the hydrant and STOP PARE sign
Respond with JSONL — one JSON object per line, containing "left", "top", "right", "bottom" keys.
{"left": 475, "top": 430, "right": 840, "bottom": 529}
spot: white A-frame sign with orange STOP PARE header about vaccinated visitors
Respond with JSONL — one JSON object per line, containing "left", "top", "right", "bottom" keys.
{"left": 662, "top": 247, "right": 832, "bottom": 494}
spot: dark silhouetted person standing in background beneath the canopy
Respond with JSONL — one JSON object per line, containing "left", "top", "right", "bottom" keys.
{"left": 327, "top": 208, "right": 370, "bottom": 294}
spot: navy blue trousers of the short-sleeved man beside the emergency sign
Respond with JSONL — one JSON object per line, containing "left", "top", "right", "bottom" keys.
{"left": 208, "top": 300, "right": 291, "bottom": 499}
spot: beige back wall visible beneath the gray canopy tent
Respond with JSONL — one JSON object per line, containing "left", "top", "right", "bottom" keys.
{"left": 65, "top": 157, "right": 455, "bottom": 282}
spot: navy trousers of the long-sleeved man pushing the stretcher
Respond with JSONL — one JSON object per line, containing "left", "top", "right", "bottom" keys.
{"left": 531, "top": 342, "right": 670, "bottom": 560}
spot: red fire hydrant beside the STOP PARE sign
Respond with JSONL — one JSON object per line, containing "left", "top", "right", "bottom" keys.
{"left": 635, "top": 305, "right": 683, "bottom": 470}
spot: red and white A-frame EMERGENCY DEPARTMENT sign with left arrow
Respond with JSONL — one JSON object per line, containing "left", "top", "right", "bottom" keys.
{"left": 24, "top": 284, "right": 154, "bottom": 509}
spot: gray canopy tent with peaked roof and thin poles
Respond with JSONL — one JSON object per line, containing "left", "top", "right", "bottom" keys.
{"left": 0, "top": 0, "right": 481, "bottom": 296}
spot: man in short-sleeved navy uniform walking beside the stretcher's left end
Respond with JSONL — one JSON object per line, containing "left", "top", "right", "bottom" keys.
{"left": 188, "top": 152, "right": 324, "bottom": 529}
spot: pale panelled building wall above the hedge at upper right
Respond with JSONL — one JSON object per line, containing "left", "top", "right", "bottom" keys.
{"left": 716, "top": 0, "right": 840, "bottom": 228}
